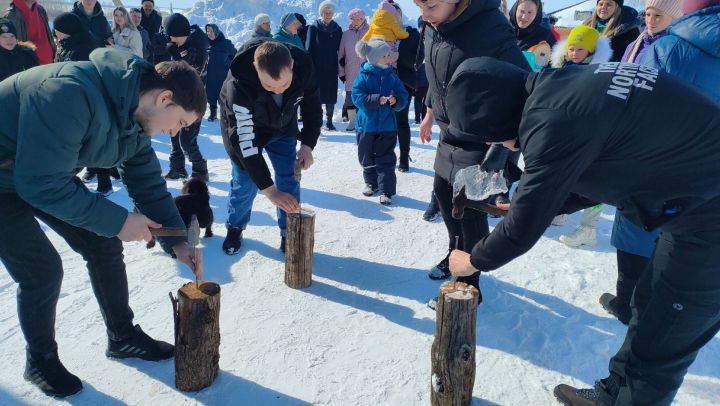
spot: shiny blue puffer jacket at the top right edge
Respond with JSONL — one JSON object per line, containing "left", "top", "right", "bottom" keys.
{"left": 643, "top": 6, "right": 720, "bottom": 103}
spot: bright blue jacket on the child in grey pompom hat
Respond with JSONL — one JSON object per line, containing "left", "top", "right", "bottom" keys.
{"left": 352, "top": 62, "right": 408, "bottom": 133}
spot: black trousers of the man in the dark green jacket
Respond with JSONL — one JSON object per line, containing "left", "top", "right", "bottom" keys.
{"left": 0, "top": 189, "right": 133, "bottom": 354}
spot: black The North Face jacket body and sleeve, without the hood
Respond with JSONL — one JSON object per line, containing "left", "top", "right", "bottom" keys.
{"left": 470, "top": 63, "right": 720, "bottom": 271}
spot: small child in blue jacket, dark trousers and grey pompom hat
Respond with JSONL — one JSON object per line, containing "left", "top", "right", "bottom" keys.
{"left": 352, "top": 39, "right": 408, "bottom": 205}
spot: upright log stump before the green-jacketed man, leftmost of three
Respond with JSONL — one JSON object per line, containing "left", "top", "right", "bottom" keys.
{"left": 170, "top": 282, "right": 220, "bottom": 391}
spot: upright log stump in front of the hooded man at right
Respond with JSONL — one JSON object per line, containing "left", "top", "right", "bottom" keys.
{"left": 430, "top": 282, "right": 479, "bottom": 406}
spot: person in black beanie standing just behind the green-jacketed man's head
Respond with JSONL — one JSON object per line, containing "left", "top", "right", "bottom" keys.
{"left": 165, "top": 13, "right": 210, "bottom": 182}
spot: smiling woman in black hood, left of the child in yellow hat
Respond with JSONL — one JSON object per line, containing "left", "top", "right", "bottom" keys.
{"left": 508, "top": 0, "right": 556, "bottom": 51}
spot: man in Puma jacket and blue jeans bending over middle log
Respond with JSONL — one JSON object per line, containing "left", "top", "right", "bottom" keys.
{"left": 220, "top": 40, "right": 322, "bottom": 255}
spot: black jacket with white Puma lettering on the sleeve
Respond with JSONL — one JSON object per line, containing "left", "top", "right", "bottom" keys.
{"left": 220, "top": 39, "right": 322, "bottom": 190}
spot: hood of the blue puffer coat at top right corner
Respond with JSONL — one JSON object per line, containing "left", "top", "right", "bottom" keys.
{"left": 667, "top": 6, "right": 720, "bottom": 58}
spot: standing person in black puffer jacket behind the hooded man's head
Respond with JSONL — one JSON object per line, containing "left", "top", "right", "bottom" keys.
{"left": 416, "top": 0, "right": 530, "bottom": 298}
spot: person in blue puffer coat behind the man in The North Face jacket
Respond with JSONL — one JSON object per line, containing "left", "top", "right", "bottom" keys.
{"left": 600, "top": 0, "right": 720, "bottom": 324}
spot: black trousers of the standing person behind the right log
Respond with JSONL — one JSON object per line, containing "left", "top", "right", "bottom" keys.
{"left": 433, "top": 175, "right": 490, "bottom": 290}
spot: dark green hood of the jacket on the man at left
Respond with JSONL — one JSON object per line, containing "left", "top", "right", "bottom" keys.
{"left": 90, "top": 48, "right": 152, "bottom": 136}
